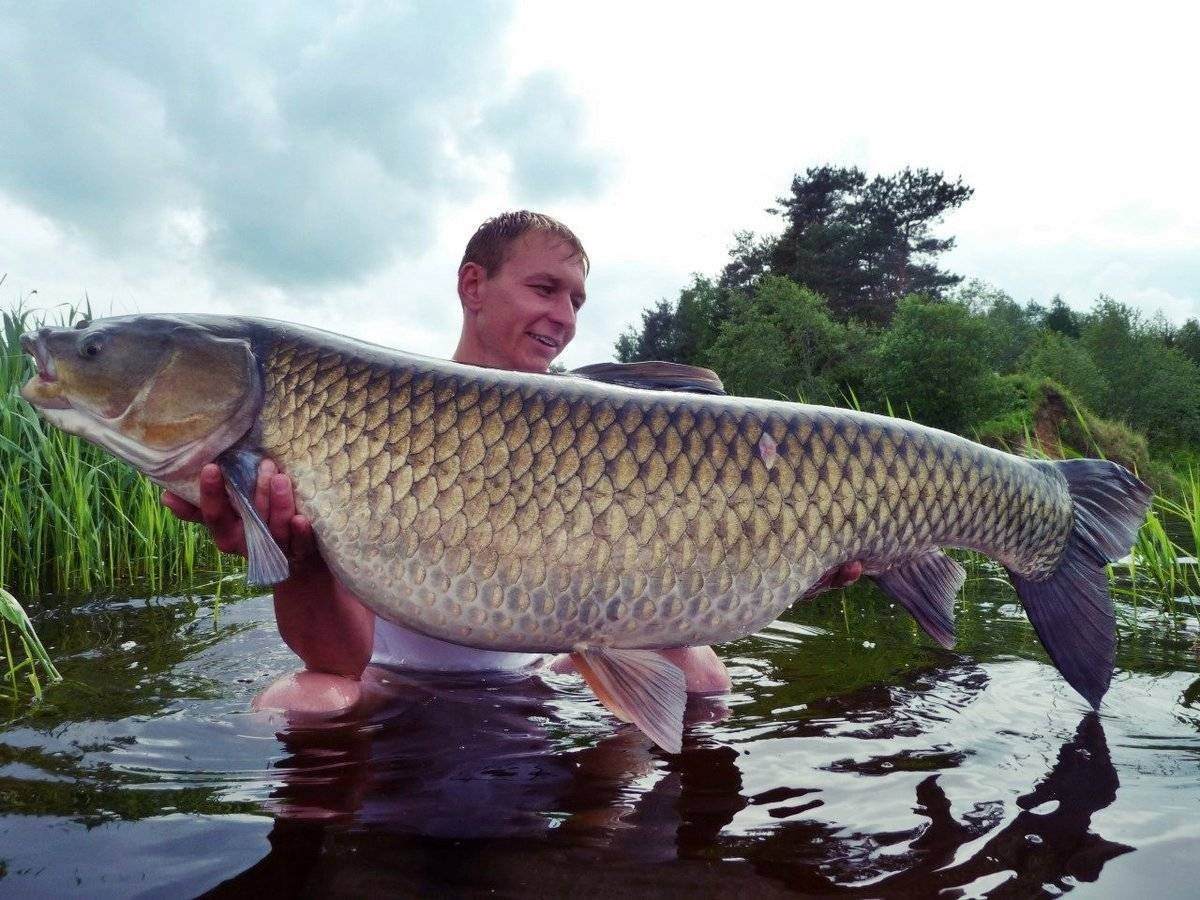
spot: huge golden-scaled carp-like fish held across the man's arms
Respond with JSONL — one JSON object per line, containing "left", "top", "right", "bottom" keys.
{"left": 22, "top": 316, "right": 1150, "bottom": 751}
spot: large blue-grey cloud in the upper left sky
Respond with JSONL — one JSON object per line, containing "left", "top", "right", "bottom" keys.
{"left": 0, "top": 2, "right": 598, "bottom": 287}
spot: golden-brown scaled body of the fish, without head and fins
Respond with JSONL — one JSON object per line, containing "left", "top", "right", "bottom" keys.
{"left": 262, "top": 341, "right": 1072, "bottom": 650}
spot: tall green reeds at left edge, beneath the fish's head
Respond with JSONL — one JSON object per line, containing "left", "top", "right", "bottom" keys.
{"left": 0, "top": 308, "right": 221, "bottom": 596}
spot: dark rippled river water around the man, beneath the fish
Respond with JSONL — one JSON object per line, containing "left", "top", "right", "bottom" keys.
{"left": 0, "top": 572, "right": 1200, "bottom": 898}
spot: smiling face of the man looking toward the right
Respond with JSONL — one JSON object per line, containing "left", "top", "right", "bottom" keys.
{"left": 460, "top": 232, "right": 584, "bottom": 372}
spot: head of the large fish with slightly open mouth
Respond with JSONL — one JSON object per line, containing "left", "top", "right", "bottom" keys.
{"left": 20, "top": 316, "right": 262, "bottom": 484}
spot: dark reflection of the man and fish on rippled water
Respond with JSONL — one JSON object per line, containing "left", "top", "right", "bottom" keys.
{"left": 216, "top": 673, "right": 1133, "bottom": 895}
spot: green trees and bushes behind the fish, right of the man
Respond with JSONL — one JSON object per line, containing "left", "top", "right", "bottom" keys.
{"left": 617, "top": 166, "right": 1200, "bottom": 472}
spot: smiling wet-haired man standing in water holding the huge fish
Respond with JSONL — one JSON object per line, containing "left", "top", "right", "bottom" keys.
{"left": 163, "top": 211, "right": 730, "bottom": 713}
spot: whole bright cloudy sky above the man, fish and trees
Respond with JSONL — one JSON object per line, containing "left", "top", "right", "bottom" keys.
{"left": 0, "top": 0, "right": 1200, "bottom": 365}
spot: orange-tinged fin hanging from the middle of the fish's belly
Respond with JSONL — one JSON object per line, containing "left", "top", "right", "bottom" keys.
{"left": 571, "top": 647, "right": 688, "bottom": 754}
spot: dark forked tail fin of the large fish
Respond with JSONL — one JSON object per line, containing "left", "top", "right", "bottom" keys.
{"left": 1009, "top": 460, "right": 1152, "bottom": 709}
